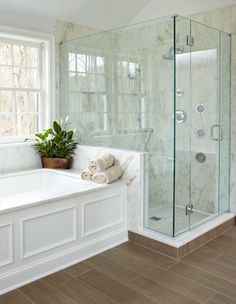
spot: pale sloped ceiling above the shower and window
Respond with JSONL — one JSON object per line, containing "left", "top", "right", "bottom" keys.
{"left": 0, "top": 0, "right": 236, "bottom": 29}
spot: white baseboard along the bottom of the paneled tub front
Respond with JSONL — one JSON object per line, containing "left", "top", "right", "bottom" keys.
{"left": 0, "top": 228, "right": 128, "bottom": 295}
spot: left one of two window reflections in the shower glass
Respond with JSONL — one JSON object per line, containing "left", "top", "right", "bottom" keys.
{"left": 68, "top": 53, "right": 108, "bottom": 131}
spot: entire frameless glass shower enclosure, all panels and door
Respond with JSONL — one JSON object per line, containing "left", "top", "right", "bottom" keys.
{"left": 60, "top": 16, "right": 231, "bottom": 237}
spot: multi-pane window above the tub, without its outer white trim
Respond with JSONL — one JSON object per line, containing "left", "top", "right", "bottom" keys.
{"left": 0, "top": 32, "right": 49, "bottom": 142}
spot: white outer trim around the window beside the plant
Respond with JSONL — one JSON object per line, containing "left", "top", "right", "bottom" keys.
{"left": 0, "top": 26, "right": 56, "bottom": 145}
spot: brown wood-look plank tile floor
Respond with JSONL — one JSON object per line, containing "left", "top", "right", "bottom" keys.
{"left": 0, "top": 226, "right": 236, "bottom": 304}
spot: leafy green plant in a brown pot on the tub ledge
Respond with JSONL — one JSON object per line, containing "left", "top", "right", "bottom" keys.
{"left": 31, "top": 121, "right": 78, "bottom": 169}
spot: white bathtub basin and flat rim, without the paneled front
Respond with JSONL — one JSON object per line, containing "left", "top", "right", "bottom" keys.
{"left": 0, "top": 169, "right": 107, "bottom": 214}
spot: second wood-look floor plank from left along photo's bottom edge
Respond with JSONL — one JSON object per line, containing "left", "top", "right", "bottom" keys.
{"left": 19, "top": 280, "right": 76, "bottom": 304}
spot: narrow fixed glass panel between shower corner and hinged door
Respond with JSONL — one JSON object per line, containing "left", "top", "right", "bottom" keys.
{"left": 173, "top": 17, "right": 191, "bottom": 236}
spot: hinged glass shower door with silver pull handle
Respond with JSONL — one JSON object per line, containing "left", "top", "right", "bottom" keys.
{"left": 190, "top": 21, "right": 223, "bottom": 227}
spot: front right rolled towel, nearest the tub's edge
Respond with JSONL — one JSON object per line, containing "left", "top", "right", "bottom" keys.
{"left": 92, "top": 166, "right": 123, "bottom": 184}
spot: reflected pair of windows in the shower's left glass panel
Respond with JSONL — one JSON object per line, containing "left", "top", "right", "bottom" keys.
{"left": 65, "top": 50, "right": 146, "bottom": 136}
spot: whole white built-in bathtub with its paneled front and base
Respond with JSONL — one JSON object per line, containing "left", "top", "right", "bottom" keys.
{"left": 0, "top": 169, "right": 128, "bottom": 294}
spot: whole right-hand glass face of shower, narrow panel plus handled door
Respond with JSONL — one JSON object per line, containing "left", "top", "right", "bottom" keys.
{"left": 174, "top": 17, "right": 224, "bottom": 236}
